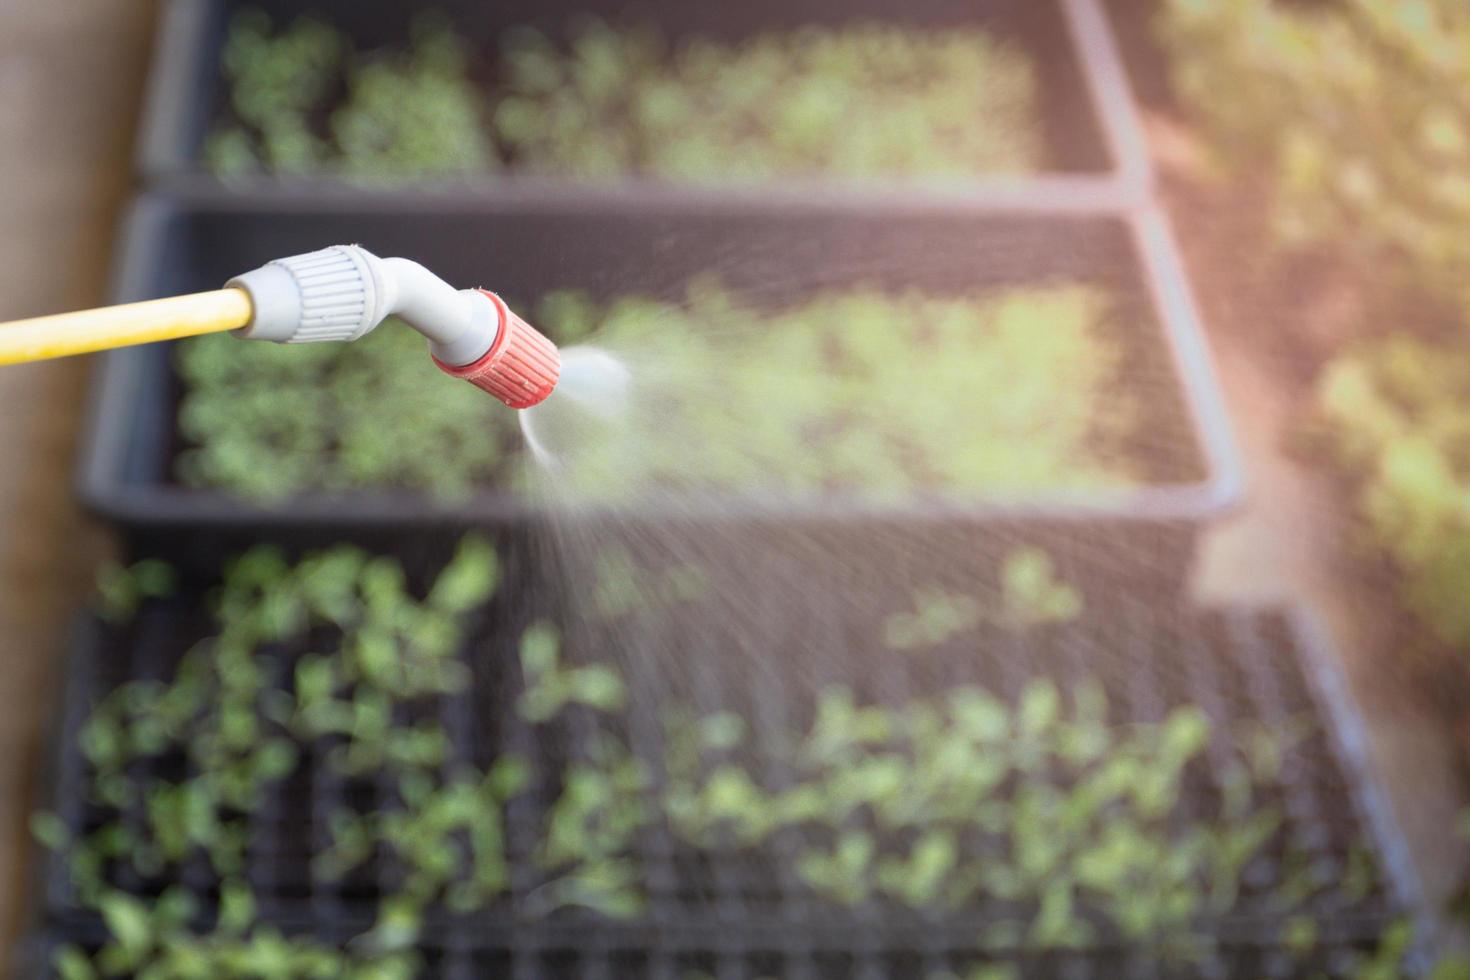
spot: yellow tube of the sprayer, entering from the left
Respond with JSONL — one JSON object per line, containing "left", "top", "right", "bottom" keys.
{"left": 0, "top": 289, "right": 254, "bottom": 364}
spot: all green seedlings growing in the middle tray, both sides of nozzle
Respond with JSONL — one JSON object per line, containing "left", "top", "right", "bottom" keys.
{"left": 176, "top": 281, "right": 1138, "bottom": 501}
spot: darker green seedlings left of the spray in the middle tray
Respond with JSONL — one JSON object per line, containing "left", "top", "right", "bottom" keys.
{"left": 175, "top": 322, "right": 517, "bottom": 501}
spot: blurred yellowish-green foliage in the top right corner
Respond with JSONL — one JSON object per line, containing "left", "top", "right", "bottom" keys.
{"left": 1160, "top": 0, "right": 1470, "bottom": 309}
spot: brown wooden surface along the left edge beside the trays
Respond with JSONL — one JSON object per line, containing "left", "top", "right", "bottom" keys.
{"left": 0, "top": 0, "right": 153, "bottom": 976}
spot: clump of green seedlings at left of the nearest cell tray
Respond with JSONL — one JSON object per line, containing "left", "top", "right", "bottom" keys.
{"left": 35, "top": 538, "right": 505, "bottom": 980}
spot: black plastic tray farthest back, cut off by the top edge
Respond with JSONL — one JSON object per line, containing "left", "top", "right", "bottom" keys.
{"left": 140, "top": 0, "right": 1150, "bottom": 201}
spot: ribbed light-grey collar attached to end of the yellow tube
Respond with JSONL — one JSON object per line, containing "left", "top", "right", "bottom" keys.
{"left": 228, "top": 245, "right": 387, "bottom": 344}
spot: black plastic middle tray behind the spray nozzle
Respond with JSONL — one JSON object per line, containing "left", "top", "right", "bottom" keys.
{"left": 81, "top": 194, "right": 1241, "bottom": 583}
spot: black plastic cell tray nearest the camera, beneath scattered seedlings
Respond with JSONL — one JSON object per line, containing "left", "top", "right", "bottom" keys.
{"left": 26, "top": 564, "right": 1421, "bottom": 980}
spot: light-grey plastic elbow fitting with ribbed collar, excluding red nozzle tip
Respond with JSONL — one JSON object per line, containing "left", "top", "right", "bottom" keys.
{"left": 226, "top": 245, "right": 503, "bottom": 367}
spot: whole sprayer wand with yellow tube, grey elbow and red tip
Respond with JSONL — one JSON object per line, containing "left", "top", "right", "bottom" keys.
{"left": 0, "top": 245, "right": 562, "bottom": 408}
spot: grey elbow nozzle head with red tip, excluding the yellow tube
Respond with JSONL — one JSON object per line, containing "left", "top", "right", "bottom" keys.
{"left": 228, "top": 245, "right": 562, "bottom": 408}
